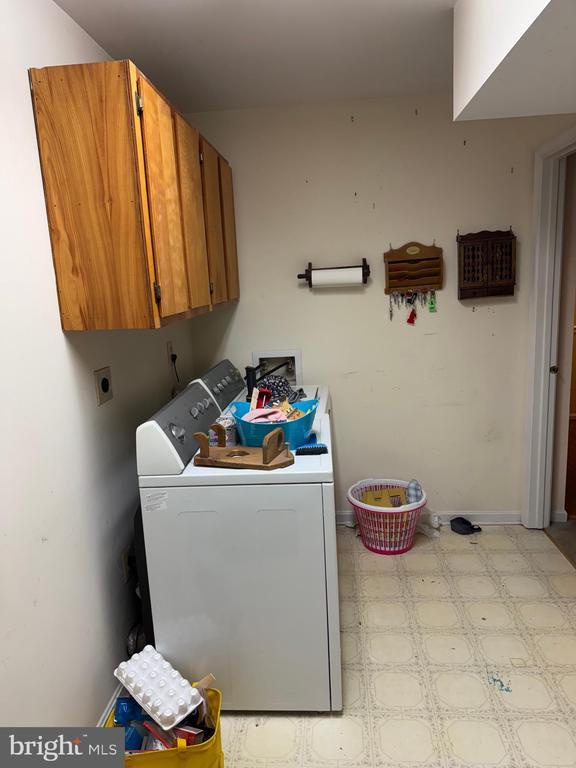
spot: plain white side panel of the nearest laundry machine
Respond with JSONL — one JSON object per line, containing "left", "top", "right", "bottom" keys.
{"left": 141, "top": 485, "right": 330, "bottom": 711}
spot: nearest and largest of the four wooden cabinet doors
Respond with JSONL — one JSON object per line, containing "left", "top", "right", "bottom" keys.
{"left": 138, "top": 75, "right": 189, "bottom": 317}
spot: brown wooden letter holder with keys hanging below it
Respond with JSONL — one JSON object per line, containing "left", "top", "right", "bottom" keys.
{"left": 384, "top": 243, "right": 444, "bottom": 294}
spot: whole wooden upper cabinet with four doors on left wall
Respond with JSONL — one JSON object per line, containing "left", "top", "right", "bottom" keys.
{"left": 30, "top": 61, "right": 237, "bottom": 331}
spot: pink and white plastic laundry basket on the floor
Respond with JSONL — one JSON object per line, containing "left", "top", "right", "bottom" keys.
{"left": 348, "top": 480, "right": 426, "bottom": 555}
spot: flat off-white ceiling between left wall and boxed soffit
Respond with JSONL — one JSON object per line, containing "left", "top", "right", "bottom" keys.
{"left": 56, "top": 0, "right": 455, "bottom": 112}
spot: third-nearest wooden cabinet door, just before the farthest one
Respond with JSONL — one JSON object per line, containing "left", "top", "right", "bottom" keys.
{"left": 200, "top": 138, "right": 228, "bottom": 304}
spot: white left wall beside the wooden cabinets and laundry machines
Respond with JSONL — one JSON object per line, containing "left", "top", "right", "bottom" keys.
{"left": 0, "top": 0, "right": 199, "bottom": 725}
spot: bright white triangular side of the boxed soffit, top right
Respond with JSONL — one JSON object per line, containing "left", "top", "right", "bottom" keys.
{"left": 454, "top": 0, "right": 551, "bottom": 118}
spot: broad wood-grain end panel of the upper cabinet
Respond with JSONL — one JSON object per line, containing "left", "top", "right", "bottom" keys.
{"left": 30, "top": 61, "right": 155, "bottom": 330}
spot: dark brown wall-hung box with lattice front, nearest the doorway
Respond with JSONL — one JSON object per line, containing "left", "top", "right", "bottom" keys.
{"left": 456, "top": 228, "right": 516, "bottom": 299}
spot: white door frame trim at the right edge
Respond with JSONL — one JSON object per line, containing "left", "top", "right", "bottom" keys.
{"left": 522, "top": 126, "right": 576, "bottom": 528}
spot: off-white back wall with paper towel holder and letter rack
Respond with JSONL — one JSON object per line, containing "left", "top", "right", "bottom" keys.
{"left": 190, "top": 96, "right": 575, "bottom": 511}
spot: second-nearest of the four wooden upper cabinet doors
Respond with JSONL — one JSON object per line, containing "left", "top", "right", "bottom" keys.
{"left": 174, "top": 114, "right": 210, "bottom": 309}
